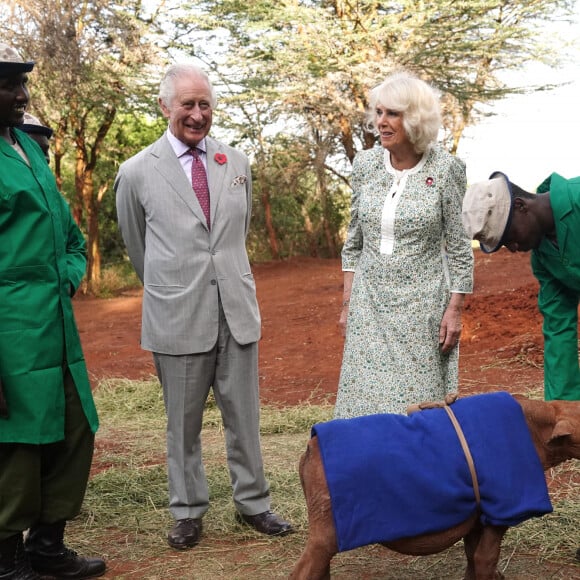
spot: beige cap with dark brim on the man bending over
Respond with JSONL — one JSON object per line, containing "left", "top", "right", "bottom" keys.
{"left": 461, "top": 171, "right": 513, "bottom": 254}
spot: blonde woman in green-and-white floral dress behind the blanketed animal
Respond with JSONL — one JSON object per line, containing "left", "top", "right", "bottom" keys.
{"left": 335, "top": 72, "right": 473, "bottom": 418}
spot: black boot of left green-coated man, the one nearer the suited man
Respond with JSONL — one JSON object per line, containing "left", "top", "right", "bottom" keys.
{"left": 28, "top": 547, "right": 107, "bottom": 580}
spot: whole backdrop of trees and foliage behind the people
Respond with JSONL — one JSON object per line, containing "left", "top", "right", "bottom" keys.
{"left": 0, "top": 0, "right": 575, "bottom": 266}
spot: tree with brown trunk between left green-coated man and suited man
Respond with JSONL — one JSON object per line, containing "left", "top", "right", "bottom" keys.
{"left": 0, "top": 0, "right": 164, "bottom": 287}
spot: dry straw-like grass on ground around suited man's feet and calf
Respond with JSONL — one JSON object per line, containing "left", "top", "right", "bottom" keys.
{"left": 68, "top": 379, "right": 580, "bottom": 580}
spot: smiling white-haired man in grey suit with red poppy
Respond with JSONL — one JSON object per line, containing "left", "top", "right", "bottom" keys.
{"left": 115, "top": 64, "right": 292, "bottom": 549}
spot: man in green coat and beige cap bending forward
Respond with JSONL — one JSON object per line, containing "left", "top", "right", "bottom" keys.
{"left": 463, "top": 171, "right": 580, "bottom": 401}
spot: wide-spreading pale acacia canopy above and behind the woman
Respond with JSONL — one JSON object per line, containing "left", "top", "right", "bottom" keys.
{"left": 174, "top": 0, "right": 574, "bottom": 247}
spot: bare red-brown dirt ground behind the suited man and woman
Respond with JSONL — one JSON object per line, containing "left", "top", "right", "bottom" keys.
{"left": 74, "top": 249, "right": 577, "bottom": 578}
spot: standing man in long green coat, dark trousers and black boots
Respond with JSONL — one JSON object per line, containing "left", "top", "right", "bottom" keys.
{"left": 0, "top": 44, "right": 106, "bottom": 580}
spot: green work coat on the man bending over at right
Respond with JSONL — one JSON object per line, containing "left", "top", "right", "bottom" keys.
{"left": 532, "top": 173, "right": 580, "bottom": 401}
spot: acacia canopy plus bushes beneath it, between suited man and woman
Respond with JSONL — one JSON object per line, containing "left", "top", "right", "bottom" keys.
{"left": 174, "top": 0, "right": 573, "bottom": 259}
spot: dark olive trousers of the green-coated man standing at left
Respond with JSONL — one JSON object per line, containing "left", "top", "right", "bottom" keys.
{"left": 0, "top": 369, "right": 95, "bottom": 540}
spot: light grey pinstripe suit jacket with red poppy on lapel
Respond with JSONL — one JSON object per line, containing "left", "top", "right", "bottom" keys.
{"left": 115, "top": 134, "right": 260, "bottom": 355}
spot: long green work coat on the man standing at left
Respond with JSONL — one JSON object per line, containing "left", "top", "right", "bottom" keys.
{"left": 0, "top": 130, "right": 98, "bottom": 444}
